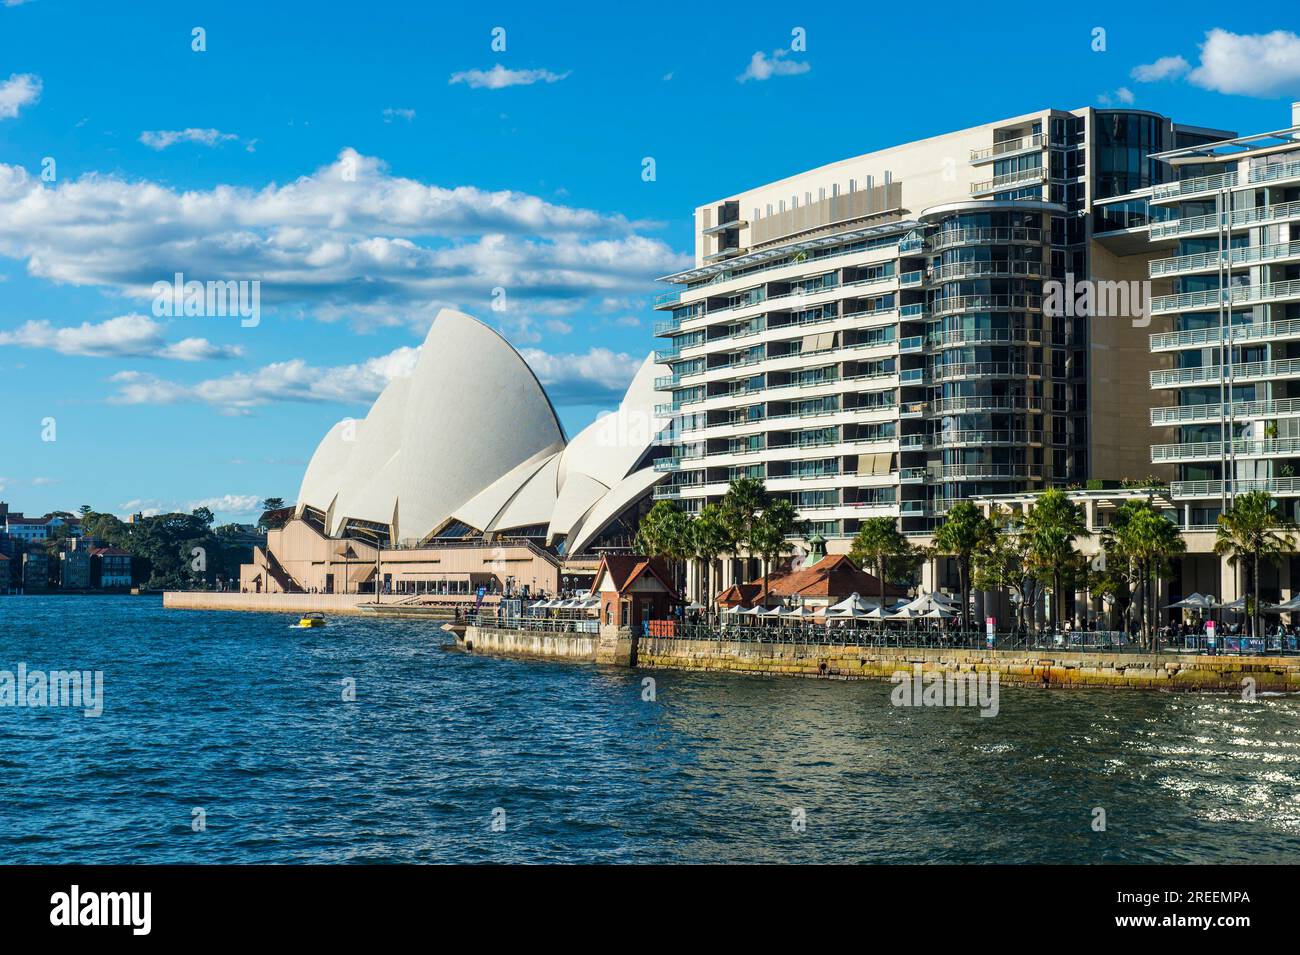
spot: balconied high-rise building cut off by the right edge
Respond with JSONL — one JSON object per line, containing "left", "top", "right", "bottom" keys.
{"left": 1131, "top": 104, "right": 1300, "bottom": 528}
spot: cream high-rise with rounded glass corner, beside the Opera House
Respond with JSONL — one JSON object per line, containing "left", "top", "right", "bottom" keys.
{"left": 655, "top": 108, "right": 1234, "bottom": 544}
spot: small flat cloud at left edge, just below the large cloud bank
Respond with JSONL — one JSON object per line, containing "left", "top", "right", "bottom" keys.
{"left": 0, "top": 314, "right": 242, "bottom": 361}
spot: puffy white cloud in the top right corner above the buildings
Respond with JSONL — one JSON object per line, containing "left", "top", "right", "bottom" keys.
{"left": 1187, "top": 30, "right": 1300, "bottom": 96}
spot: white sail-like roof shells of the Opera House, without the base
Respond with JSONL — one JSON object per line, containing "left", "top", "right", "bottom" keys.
{"left": 295, "top": 309, "right": 667, "bottom": 555}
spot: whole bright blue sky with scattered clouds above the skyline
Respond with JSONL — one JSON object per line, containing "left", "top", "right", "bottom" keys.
{"left": 0, "top": 0, "right": 1300, "bottom": 520}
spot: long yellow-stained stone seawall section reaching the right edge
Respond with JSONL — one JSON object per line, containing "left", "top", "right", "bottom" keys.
{"left": 637, "top": 637, "right": 1300, "bottom": 693}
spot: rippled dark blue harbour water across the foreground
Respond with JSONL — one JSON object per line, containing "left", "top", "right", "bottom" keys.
{"left": 0, "top": 596, "right": 1300, "bottom": 863}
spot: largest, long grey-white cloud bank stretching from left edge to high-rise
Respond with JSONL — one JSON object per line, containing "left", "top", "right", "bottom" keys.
{"left": 0, "top": 149, "right": 690, "bottom": 330}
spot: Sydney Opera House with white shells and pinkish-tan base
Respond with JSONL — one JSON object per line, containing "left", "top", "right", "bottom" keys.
{"left": 241, "top": 309, "right": 666, "bottom": 595}
